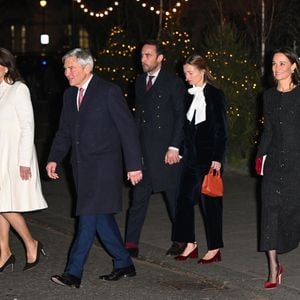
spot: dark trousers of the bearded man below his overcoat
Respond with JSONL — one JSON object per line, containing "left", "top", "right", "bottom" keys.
{"left": 125, "top": 172, "right": 178, "bottom": 245}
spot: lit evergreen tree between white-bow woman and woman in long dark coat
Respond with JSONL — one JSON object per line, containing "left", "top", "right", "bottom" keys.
{"left": 205, "top": 24, "right": 261, "bottom": 166}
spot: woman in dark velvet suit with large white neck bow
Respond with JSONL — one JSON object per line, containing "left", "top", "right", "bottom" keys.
{"left": 174, "top": 55, "right": 227, "bottom": 264}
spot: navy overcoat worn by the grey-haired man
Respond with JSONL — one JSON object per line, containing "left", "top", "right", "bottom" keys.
{"left": 48, "top": 75, "right": 141, "bottom": 215}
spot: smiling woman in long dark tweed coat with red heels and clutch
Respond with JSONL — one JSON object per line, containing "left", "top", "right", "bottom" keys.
{"left": 256, "top": 48, "right": 300, "bottom": 289}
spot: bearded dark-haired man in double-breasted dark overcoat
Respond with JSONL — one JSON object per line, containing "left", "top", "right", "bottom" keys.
{"left": 125, "top": 40, "right": 185, "bottom": 257}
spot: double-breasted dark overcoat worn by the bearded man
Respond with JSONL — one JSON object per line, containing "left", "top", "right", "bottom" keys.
{"left": 135, "top": 69, "right": 185, "bottom": 192}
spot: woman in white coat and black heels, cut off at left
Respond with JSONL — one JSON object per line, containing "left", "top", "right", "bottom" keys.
{"left": 0, "top": 48, "right": 47, "bottom": 272}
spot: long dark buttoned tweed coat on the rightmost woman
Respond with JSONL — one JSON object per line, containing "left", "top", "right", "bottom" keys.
{"left": 257, "top": 86, "right": 300, "bottom": 253}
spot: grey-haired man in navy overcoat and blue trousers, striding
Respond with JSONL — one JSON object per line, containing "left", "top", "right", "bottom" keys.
{"left": 46, "top": 48, "right": 142, "bottom": 288}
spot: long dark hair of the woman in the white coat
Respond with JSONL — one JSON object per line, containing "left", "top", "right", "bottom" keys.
{"left": 0, "top": 48, "right": 23, "bottom": 84}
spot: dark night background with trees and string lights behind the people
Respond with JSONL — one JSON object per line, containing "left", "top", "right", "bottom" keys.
{"left": 0, "top": 0, "right": 300, "bottom": 168}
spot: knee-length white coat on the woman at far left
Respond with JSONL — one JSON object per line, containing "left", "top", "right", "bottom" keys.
{"left": 0, "top": 81, "right": 47, "bottom": 212}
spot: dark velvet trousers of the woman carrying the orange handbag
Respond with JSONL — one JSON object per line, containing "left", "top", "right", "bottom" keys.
{"left": 173, "top": 165, "right": 224, "bottom": 250}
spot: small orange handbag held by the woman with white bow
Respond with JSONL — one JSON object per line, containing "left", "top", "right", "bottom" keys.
{"left": 201, "top": 168, "right": 224, "bottom": 197}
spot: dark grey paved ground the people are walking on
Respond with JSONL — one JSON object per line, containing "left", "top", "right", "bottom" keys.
{"left": 0, "top": 168, "right": 300, "bottom": 300}
